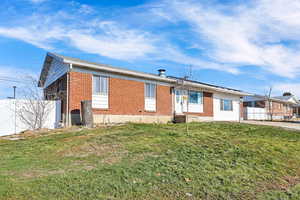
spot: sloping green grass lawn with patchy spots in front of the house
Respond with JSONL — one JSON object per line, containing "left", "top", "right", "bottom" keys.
{"left": 0, "top": 123, "right": 300, "bottom": 200}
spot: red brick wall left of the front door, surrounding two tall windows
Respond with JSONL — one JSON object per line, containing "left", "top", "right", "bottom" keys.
{"left": 69, "top": 72, "right": 172, "bottom": 115}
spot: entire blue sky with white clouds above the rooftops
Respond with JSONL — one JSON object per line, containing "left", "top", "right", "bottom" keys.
{"left": 0, "top": 0, "right": 300, "bottom": 98}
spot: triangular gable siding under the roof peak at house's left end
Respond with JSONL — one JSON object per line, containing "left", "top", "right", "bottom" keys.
{"left": 45, "top": 58, "right": 69, "bottom": 87}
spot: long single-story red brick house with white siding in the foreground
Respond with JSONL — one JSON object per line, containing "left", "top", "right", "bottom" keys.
{"left": 39, "top": 53, "right": 248, "bottom": 125}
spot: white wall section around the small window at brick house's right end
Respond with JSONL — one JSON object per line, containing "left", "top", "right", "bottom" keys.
{"left": 213, "top": 93, "right": 240, "bottom": 121}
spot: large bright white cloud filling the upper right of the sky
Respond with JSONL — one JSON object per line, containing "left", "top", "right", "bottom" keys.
{"left": 159, "top": 0, "right": 300, "bottom": 78}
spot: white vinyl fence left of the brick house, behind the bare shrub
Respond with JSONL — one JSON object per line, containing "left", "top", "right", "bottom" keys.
{"left": 0, "top": 99, "right": 61, "bottom": 136}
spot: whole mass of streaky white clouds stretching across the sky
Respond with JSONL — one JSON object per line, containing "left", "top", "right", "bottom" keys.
{"left": 0, "top": 0, "right": 300, "bottom": 78}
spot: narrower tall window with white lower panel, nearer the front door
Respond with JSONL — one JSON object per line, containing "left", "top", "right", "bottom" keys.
{"left": 144, "top": 83, "right": 157, "bottom": 112}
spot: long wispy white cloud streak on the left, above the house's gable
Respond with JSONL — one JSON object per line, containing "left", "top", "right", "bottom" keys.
{"left": 0, "top": 17, "right": 154, "bottom": 60}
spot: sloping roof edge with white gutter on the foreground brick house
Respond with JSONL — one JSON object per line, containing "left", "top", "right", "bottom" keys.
{"left": 39, "top": 53, "right": 250, "bottom": 96}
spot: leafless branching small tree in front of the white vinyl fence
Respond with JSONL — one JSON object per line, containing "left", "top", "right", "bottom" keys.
{"left": 16, "top": 76, "right": 51, "bottom": 130}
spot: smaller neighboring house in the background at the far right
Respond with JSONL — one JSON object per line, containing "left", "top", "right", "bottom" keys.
{"left": 243, "top": 95, "right": 298, "bottom": 120}
